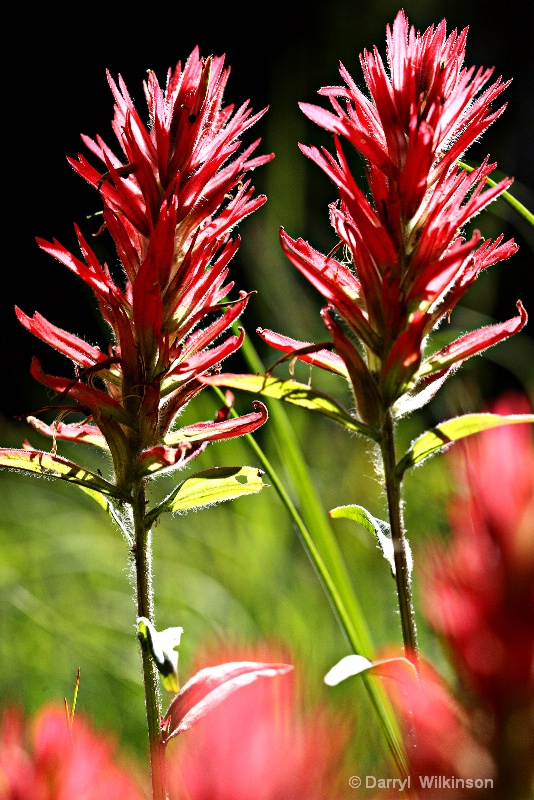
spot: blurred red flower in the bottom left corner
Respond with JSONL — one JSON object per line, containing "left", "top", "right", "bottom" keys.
{"left": 0, "top": 706, "right": 145, "bottom": 800}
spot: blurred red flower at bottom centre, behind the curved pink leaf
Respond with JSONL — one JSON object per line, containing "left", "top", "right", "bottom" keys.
{"left": 167, "top": 651, "right": 349, "bottom": 800}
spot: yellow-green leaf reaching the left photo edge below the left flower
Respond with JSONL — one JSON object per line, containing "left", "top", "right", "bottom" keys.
{"left": 0, "top": 448, "right": 130, "bottom": 505}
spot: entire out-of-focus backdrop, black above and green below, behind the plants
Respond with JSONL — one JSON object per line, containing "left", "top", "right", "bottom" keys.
{"left": 0, "top": 0, "right": 534, "bottom": 780}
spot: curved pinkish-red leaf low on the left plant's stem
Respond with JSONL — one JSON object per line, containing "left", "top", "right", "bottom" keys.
{"left": 166, "top": 661, "right": 293, "bottom": 741}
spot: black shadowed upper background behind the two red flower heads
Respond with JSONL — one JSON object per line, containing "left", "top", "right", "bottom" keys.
{"left": 0, "top": 0, "right": 534, "bottom": 419}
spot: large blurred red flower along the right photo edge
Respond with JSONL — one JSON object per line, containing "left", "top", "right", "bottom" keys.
{"left": 423, "top": 393, "right": 534, "bottom": 798}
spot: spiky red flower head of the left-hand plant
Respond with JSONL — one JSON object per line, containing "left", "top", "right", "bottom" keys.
{"left": 13, "top": 49, "right": 272, "bottom": 487}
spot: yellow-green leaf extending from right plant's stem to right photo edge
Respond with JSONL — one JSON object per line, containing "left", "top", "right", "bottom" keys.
{"left": 396, "top": 414, "right": 534, "bottom": 479}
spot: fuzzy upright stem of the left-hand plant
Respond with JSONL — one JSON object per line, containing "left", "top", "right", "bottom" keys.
{"left": 132, "top": 481, "right": 167, "bottom": 800}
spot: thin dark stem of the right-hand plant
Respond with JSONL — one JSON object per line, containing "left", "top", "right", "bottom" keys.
{"left": 381, "top": 409, "right": 419, "bottom": 664}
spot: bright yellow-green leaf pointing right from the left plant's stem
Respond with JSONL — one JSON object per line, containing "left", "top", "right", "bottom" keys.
{"left": 148, "top": 467, "right": 267, "bottom": 524}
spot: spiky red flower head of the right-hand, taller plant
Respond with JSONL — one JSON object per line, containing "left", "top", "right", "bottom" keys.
{"left": 259, "top": 11, "right": 527, "bottom": 424}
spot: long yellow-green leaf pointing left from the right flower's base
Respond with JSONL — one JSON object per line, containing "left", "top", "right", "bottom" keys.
{"left": 205, "top": 373, "right": 380, "bottom": 442}
